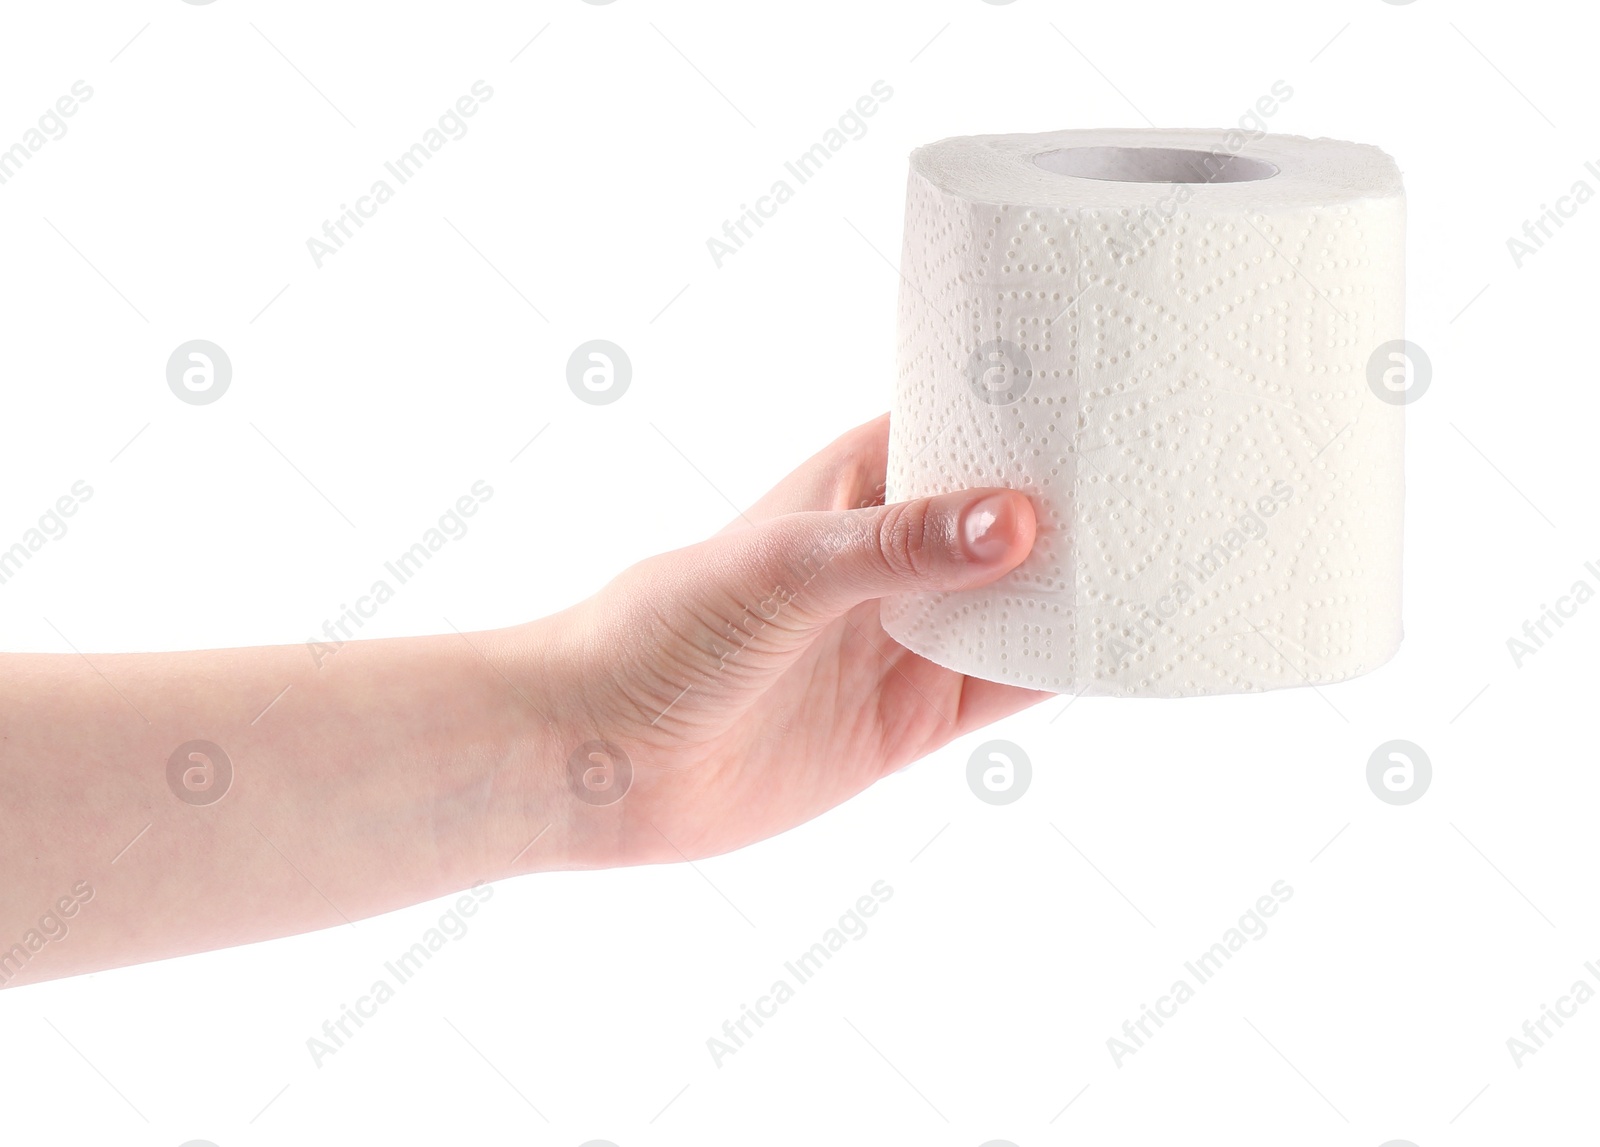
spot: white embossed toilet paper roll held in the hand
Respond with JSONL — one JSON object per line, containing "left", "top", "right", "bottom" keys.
{"left": 882, "top": 130, "right": 1426, "bottom": 696}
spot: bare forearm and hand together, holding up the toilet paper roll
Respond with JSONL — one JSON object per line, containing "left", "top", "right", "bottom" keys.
{"left": 0, "top": 416, "right": 1050, "bottom": 987}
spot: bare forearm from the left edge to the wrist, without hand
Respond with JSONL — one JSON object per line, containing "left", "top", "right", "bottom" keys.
{"left": 0, "top": 627, "right": 570, "bottom": 985}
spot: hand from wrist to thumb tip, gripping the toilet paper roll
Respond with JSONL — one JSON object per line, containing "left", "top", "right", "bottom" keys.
{"left": 528, "top": 416, "right": 1050, "bottom": 867}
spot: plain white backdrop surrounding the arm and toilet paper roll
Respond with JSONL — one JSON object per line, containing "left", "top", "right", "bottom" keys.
{"left": 0, "top": 0, "right": 1600, "bottom": 1147}
